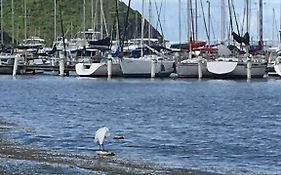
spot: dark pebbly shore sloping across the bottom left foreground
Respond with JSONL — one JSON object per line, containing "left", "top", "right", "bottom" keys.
{"left": 0, "top": 118, "right": 208, "bottom": 175}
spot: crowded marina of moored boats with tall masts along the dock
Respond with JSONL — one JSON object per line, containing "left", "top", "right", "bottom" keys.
{"left": 0, "top": 0, "right": 280, "bottom": 79}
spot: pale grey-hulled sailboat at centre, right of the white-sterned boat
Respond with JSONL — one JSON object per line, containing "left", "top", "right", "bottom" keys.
{"left": 120, "top": 0, "right": 175, "bottom": 78}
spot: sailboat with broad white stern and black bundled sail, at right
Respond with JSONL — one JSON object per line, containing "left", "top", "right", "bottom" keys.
{"left": 203, "top": 0, "right": 266, "bottom": 78}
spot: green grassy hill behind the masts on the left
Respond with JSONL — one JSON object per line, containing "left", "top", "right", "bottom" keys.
{"left": 0, "top": 0, "right": 160, "bottom": 45}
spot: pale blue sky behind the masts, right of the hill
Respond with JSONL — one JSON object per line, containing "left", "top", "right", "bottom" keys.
{"left": 121, "top": 0, "right": 281, "bottom": 44}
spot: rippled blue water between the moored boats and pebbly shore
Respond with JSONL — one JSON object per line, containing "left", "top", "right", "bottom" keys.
{"left": 0, "top": 76, "right": 281, "bottom": 174}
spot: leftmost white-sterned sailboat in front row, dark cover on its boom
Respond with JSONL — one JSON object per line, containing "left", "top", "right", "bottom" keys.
{"left": 75, "top": 0, "right": 122, "bottom": 77}
